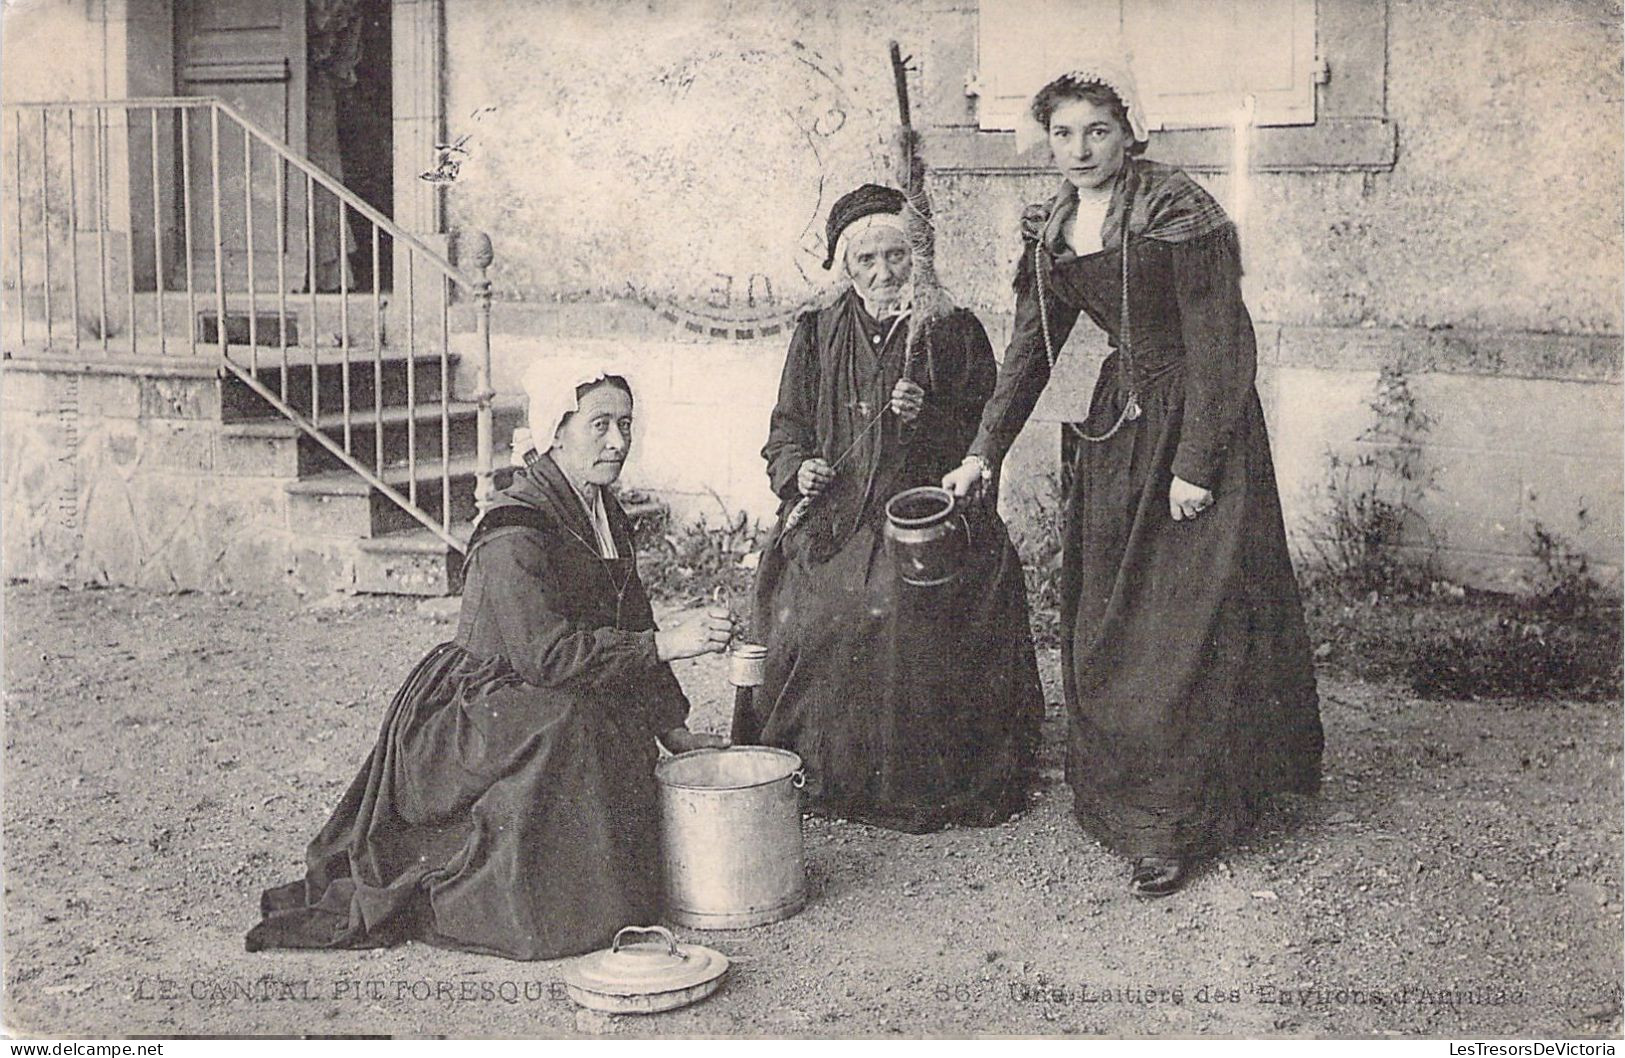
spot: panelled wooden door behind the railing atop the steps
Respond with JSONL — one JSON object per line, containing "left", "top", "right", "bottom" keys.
{"left": 176, "top": 0, "right": 305, "bottom": 293}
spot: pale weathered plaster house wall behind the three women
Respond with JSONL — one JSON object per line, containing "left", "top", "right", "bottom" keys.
{"left": 447, "top": 0, "right": 1625, "bottom": 583}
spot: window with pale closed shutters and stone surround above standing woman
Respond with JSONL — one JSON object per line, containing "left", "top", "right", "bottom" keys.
{"left": 925, "top": 0, "right": 1398, "bottom": 172}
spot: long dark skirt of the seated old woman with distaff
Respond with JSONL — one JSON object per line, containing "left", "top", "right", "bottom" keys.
{"left": 733, "top": 503, "right": 1043, "bottom": 832}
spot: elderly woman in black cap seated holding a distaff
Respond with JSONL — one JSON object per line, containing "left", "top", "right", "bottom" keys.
{"left": 733, "top": 184, "right": 1043, "bottom": 832}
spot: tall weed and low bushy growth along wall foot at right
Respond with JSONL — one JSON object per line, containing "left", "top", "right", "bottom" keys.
{"left": 1300, "top": 366, "right": 1620, "bottom": 699}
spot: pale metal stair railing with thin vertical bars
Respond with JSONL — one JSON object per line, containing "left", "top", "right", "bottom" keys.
{"left": 0, "top": 96, "right": 496, "bottom": 562}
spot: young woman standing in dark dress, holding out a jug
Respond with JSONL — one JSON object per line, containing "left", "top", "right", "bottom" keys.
{"left": 943, "top": 67, "right": 1323, "bottom": 895}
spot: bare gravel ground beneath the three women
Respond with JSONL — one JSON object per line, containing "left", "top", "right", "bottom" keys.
{"left": 3, "top": 585, "right": 1622, "bottom": 1038}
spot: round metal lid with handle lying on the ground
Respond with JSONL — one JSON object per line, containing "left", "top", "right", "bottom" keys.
{"left": 564, "top": 926, "right": 728, "bottom": 1014}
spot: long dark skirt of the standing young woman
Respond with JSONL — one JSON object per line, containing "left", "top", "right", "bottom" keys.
{"left": 1061, "top": 371, "right": 1323, "bottom": 856}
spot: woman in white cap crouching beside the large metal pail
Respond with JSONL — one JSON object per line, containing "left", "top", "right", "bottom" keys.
{"left": 247, "top": 367, "right": 733, "bottom": 959}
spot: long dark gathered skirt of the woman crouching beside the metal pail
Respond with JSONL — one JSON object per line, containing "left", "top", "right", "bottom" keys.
{"left": 247, "top": 644, "right": 660, "bottom": 959}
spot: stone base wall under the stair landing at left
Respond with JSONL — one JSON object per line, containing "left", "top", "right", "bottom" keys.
{"left": 0, "top": 359, "right": 356, "bottom": 593}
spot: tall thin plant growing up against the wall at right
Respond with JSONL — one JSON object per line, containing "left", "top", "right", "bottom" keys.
{"left": 1305, "top": 364, "right": 1433, "bottom": 598}
